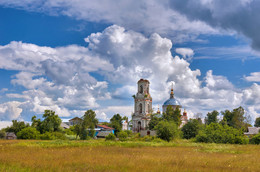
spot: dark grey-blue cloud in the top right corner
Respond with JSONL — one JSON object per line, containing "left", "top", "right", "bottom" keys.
{"left": 170, "top": 0, "right": 260, "bottom": 50}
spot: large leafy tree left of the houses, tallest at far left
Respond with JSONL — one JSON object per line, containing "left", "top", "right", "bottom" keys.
{"left": 32, "top": 110, "right": 61, "bottom": 134}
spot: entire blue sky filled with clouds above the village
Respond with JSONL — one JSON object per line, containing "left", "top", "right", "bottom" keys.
{"left": 0, "top": 0, "right": 260, "bottom": 126}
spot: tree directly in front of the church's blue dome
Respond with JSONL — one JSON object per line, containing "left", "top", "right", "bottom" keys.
{"left": 163, "top": 106, "right": 181, "bottom": 126}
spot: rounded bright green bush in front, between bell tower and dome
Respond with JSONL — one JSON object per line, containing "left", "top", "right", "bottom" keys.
{"left": 154, "top": 121, "right": 179, "bottom": 142}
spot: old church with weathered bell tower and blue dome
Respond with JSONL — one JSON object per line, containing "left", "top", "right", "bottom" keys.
{"left": 132, "top": 79, "right": 188, "bottom": 135}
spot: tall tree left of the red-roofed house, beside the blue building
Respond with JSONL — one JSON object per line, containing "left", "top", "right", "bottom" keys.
{"left": 80, "top": 110, "right": 98, "bottom": 140}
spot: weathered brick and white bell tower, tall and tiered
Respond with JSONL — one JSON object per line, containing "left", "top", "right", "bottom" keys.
{"left": 132, "top": 79, "right": 152, "bottom": 132}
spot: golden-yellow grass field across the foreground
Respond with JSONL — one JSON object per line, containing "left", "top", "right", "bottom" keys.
{"left": 0, "top": 140, "right": 260, "bottom": 171}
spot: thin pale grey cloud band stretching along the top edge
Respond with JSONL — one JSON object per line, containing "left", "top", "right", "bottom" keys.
{"left": 0, "top": 0, "right": 218, "bottom": 42}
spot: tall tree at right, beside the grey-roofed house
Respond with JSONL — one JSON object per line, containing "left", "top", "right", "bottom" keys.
{"left": 221, "top": 106, "right": 248, "bottom": 131}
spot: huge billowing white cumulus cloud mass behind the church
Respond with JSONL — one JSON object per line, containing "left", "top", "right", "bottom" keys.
{"left": 0, "top": 25, "right": 260, "bottom": 120}
